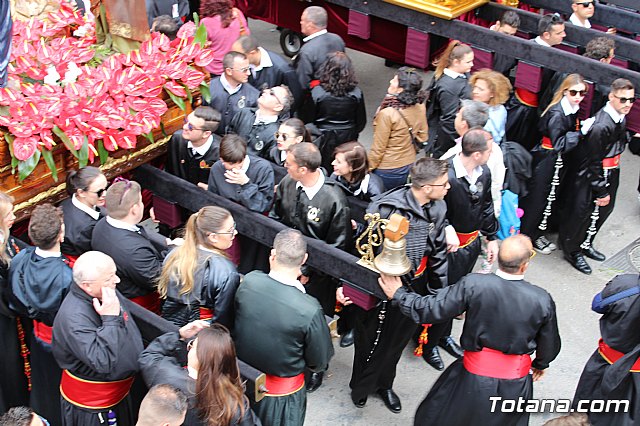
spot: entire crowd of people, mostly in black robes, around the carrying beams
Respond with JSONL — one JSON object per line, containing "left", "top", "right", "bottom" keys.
{"left": 0, "top": 0, "right": 640, "bottom": 426}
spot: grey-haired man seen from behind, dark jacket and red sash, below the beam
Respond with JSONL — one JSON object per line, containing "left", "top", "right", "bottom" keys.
{"left": 234, "top": 229, "right": 333, "bottom": 426}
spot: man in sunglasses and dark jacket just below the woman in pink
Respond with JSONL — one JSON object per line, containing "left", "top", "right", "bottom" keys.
{"left": 208, "top": 52, "right": 260, "bottom": 136}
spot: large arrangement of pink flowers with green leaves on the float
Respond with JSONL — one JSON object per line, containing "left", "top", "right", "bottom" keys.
{"left": 0, "top": 2, "right": 213, "bottom": 181}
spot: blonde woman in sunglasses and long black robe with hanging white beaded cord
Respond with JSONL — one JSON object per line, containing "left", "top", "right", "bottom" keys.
{"left": 520, "top": 74, "right": 587, "bottom": 254}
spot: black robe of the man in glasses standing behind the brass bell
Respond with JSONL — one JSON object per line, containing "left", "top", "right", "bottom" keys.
{"left": 349, "top": 185, "right": 448, "bottom": 401}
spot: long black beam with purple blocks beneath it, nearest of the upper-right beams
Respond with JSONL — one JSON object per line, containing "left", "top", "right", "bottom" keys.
{"left": 326, "top": 0, "right": 640, "bottom": 87}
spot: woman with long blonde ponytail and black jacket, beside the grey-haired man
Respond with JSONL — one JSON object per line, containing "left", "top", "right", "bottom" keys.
{"left": 158, "top": 206, "right": 240, "bottom": 327}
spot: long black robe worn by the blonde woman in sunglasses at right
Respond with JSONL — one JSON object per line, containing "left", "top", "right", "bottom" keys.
{"left": 519, "top": 102, "right": 580, "bottom": 241}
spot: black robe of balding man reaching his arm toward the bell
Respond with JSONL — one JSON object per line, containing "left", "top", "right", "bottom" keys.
{"left": 392, "top": 274, "right": 560, "bottom": 426}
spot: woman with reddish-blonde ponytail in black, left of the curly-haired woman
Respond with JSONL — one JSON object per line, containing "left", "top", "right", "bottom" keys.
{"left": 427, "top": 40, "right": 473, "bottom": 158}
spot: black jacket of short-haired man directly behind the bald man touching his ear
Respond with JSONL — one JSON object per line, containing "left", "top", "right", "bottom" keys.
{"left": 91, "top": 218, "right": 168, "bottom": 299}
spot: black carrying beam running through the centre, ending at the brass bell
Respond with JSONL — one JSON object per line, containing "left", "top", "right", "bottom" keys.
{"left": 135, "top": 164, "right": 386, "bottom": 299}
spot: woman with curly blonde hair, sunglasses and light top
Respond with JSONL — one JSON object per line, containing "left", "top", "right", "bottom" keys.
{"left": 469, "top": 69, "right": 513, "bottom": 145}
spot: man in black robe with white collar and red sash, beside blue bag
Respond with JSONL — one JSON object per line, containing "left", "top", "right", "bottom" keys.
{"left": 422, "top": 128, "right": 498, "bottom": 370}
